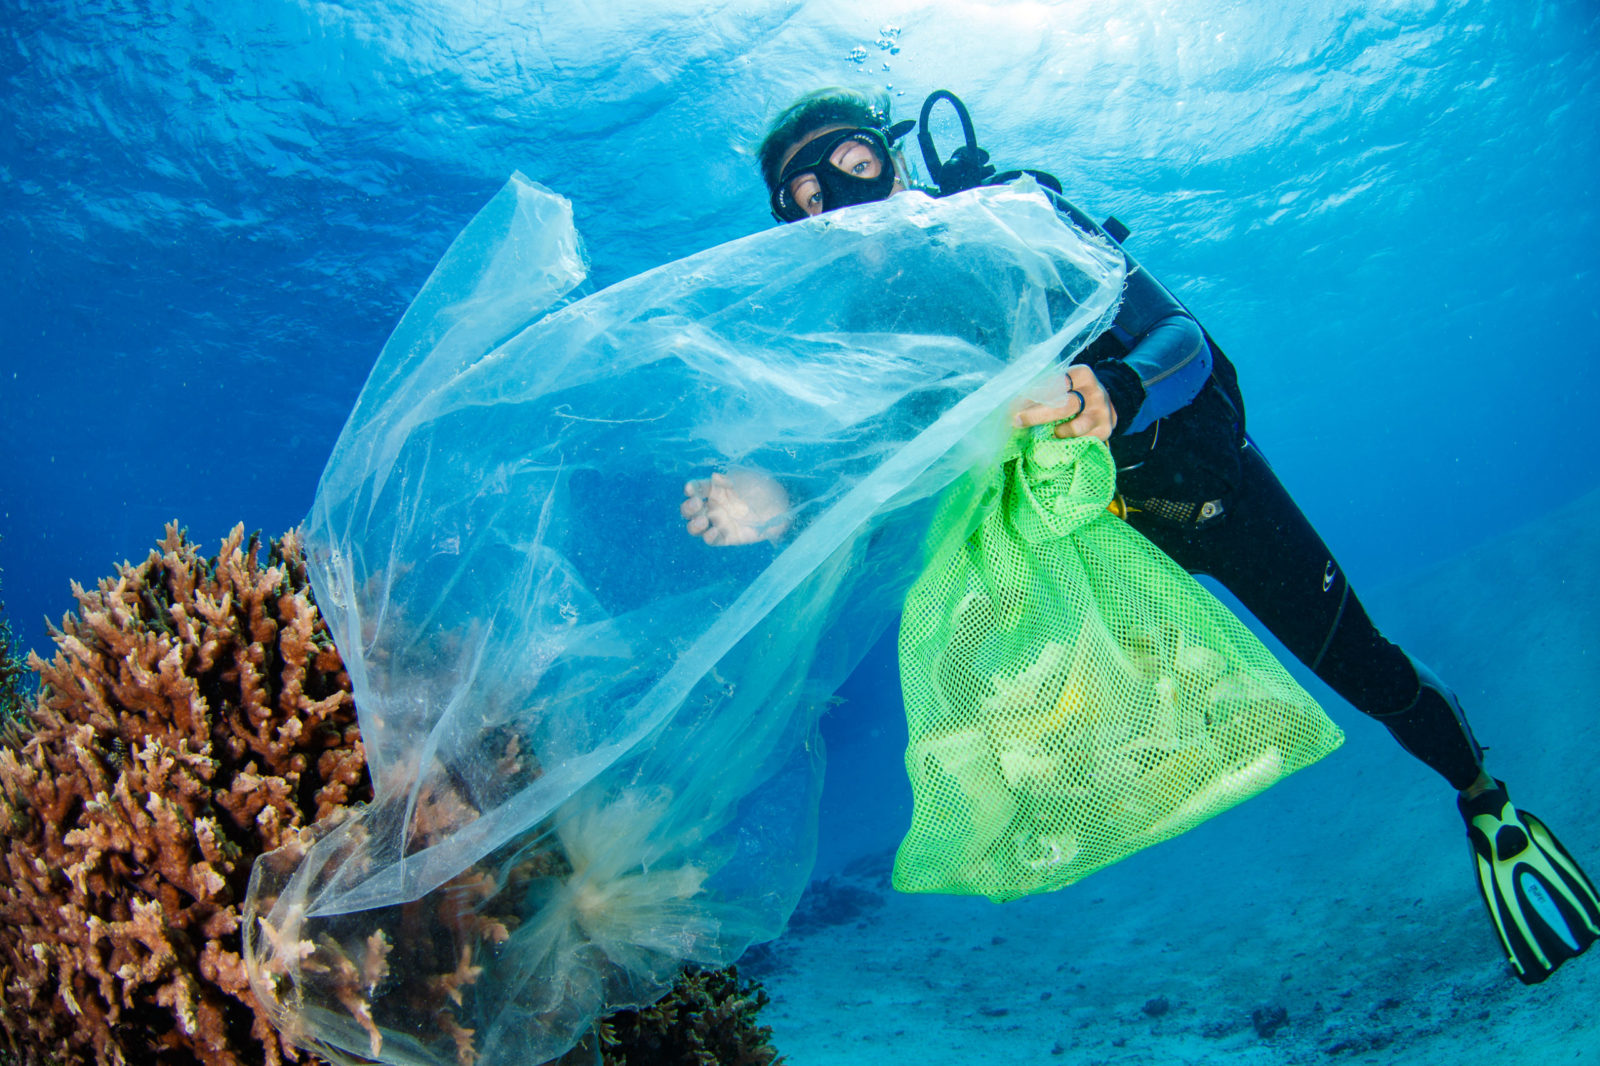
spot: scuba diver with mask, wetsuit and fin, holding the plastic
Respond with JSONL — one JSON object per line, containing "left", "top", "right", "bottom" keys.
{"left": 682, "top": 80, "right": 1600, "bottom": 984}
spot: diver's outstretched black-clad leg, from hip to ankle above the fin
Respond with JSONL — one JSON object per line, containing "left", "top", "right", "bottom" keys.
{"left": 1130, "top": 443, "right": 1491, "bottom": 792}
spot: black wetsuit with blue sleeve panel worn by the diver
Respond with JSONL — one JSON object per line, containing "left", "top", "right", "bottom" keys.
{"left": 1059, "top": 200, "right": 1482, "bottom": 789}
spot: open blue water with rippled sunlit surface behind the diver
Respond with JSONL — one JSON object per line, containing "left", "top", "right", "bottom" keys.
{"left": 0, "top": 0, "right": 1600, "bottom": 1056}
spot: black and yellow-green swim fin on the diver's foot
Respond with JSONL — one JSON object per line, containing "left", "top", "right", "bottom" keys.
{"left": 1456, "top": 781, "right": 1600, "bottom": 984}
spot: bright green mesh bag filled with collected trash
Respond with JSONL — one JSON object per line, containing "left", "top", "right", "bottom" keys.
{"left": 894, "top": 429, "right": 1344, "bottom": 900}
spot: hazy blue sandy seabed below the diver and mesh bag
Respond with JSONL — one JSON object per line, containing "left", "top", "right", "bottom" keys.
{"left": 742, "top": 493, "right": 1600, "bottom": 1066}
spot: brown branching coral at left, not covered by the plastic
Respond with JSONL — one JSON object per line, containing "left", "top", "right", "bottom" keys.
{"left": 0, "top": 523, "right": 370, "bottom": 1066}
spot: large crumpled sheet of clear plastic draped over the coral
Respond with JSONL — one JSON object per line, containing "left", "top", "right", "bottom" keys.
{"left": 245, "top": 176, "right": 1123, "bottom": 1066}
